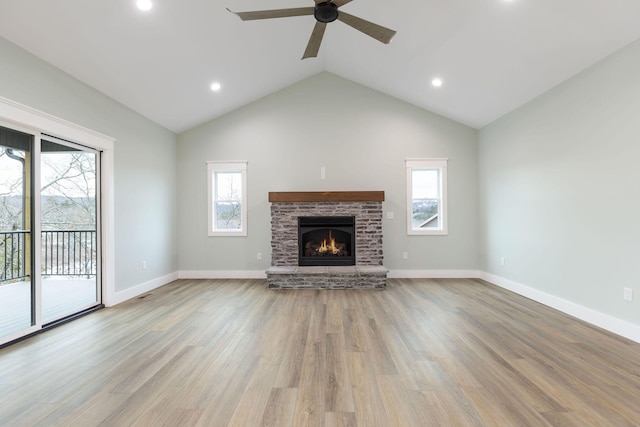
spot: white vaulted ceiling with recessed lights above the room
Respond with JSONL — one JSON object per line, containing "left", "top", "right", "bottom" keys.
{"left": 0, "top": 0, "right": 640, "bottom": 133}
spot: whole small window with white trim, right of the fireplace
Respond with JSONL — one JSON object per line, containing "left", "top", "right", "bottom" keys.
{"left": 406, "top": 159, "right": 447, "bottom": 235}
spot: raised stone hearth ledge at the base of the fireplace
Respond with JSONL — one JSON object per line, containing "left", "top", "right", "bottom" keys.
{"left": 266, "top": 265, "right": 389, "bottom": 289}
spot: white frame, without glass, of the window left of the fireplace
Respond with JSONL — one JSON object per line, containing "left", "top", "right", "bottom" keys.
{"left": 207, "top": 161, "right": 247, "bottom": 236}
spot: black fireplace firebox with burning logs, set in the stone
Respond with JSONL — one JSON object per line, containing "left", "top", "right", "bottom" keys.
{"left": 298, "top": 216, "right": 356, "bottom": 266}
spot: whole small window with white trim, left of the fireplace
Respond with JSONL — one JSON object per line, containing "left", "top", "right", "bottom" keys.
{"left": 207, "top": 162, "right": 247, "bottom": 236}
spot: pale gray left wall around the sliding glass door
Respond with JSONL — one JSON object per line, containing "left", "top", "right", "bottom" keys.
{"left": 0, "top": 38, "right": 178, "bottom": 291}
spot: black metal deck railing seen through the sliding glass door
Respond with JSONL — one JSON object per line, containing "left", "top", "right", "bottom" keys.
{"left": 0, "top": 230, "right": 98, "bottom": 282}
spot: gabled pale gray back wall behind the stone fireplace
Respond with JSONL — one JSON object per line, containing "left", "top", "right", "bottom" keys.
{"left": 178, "top": 73, "right": 478, "bottom": 271}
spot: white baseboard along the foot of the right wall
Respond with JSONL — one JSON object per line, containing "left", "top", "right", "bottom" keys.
{"left": 480, "top": 272, "right": 640, "bottom": 343}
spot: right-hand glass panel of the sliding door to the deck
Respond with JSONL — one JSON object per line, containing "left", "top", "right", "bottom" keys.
{"left": 40, "top": 137, "right": 100, "bottom": 324}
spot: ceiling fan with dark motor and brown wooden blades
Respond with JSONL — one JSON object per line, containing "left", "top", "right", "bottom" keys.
{"left": 227, "top": 0, "right": 396, "bottom": 59}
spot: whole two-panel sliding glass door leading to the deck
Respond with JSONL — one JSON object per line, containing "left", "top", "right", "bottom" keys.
{"left": 0, "top": 126, "right": 101, "bottom": 344}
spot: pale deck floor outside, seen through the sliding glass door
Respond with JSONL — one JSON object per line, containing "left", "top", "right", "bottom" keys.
{"left": 0, "top": 279, "right": 96, "bottom": 337}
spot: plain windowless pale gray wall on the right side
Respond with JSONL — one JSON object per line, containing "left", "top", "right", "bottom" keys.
{"left": 479, "top": 41, "right": 640, "bottom": 324}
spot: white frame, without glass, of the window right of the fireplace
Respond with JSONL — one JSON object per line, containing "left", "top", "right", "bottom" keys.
{"left": 405, "top": 159, "right": 449, "bottom": 236}
